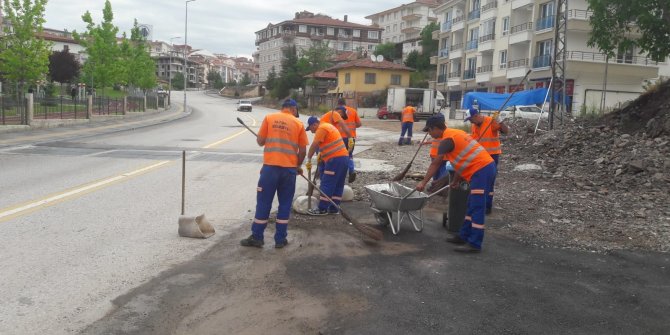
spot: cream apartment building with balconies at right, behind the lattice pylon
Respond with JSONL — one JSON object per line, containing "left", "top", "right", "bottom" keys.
{"left": 431, "top": 0, "right": 667, "bottom": 112}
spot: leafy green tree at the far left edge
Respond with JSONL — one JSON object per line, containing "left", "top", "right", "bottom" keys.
{"left": 0, "top": 0, "right": 51, "bottom": 94}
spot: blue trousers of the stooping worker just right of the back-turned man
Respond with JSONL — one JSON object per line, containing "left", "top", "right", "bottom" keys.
{"left": 319, "top": 156, "right": 349, "bottom": 211}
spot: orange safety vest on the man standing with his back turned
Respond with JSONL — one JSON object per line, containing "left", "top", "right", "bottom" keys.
{"left": 258, "top": 111, "right": 307, "bottom": 167}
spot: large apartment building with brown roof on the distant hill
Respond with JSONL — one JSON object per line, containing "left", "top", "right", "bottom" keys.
{"left": 254, "top": 11, "right": 382, "bottom": 81}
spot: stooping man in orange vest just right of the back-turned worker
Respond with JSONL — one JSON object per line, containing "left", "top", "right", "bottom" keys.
{"left": 305, "top": 116, "right": 349, "bottom": 215}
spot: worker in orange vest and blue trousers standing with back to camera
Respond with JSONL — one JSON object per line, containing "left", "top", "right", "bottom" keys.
{"left": 240, "top": 99, "right": 308, "bottom": 248}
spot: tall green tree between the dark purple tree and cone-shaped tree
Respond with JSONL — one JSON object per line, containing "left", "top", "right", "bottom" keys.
{"left": 73, "top": 0, "right": 124, "bottom": 94}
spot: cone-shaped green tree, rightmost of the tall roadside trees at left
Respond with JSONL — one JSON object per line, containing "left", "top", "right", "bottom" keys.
{"left": 119, "top": 19, "right": 157, "bottom": 90}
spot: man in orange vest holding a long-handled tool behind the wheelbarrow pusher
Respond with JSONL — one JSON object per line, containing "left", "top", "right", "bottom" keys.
{"left": 465, "top": 108, "right": 509, "bottom": 214}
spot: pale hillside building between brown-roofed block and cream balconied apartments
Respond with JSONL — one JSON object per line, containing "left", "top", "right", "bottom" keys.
{"left": 365, "top": 0, "right": 440, "bottom": 59}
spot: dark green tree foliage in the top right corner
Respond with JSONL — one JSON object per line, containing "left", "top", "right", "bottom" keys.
{"left": 588, "top": 0, "right": 670, "bottom": 62}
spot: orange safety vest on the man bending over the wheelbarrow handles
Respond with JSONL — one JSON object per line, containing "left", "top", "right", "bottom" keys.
{"left": 442, "top": 128, "right": 493, "bottom": 181}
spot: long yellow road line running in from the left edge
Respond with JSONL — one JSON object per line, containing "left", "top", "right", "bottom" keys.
{"left": 0, "top": 161, "right": 172, "bottom": 222}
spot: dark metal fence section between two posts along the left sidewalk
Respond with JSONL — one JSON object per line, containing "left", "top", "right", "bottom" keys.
{"left": 33, "top": 96, "right": 88, "bottom": 120}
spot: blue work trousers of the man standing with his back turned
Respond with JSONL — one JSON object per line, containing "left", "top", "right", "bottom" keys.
{"left": 251, "top": 165, "right": 297, "bottom": 243}
